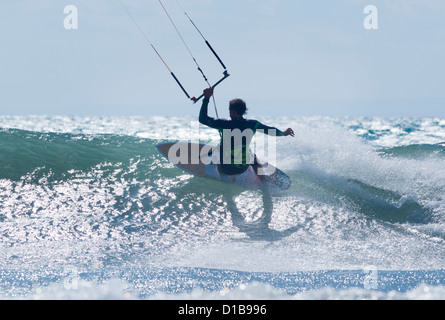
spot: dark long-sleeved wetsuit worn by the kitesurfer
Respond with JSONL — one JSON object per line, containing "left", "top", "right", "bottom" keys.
{"left": 199, "top": 98, "right": 284, "bottom": 175}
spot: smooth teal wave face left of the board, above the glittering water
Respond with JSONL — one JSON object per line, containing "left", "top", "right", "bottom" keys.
{"left": 0, "top": 129, "right": 159, "bottom": 181}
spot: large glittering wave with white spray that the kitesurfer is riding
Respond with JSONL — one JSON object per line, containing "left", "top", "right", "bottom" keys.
{"left": 0, "top": 119, "right": 445, "bottom": 297}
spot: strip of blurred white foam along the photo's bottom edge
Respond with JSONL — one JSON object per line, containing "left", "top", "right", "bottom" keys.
{"left": 9, "top": 279, "right": 445, "bottom": 300}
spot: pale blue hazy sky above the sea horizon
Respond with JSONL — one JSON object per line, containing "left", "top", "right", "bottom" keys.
{"left": 0, "top": 0, "right": 445, "bottom": 118}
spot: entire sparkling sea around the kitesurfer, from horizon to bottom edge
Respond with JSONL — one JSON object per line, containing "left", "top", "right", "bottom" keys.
{"left": 0, "top": 116, "right": 445, "bottom": 298}
